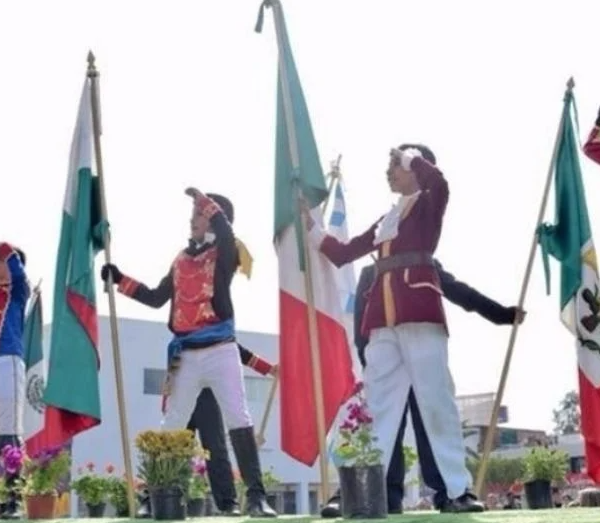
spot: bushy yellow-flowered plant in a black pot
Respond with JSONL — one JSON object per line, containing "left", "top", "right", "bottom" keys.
{"left": 135, "top": 429, "right": 198, "bottom": 521}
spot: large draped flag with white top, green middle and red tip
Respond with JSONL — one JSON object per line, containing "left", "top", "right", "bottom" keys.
{"left": 44, "top": 78, "right": 103, "bottom": 445}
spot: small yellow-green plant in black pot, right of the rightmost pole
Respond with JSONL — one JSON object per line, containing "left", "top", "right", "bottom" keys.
{"left": 523, "top": 447, "right": 569, "bottom": 509}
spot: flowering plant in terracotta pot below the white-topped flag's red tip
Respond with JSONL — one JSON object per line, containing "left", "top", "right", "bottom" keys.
{"left": 23, "top": 447, "right": 71, "bottom": 519}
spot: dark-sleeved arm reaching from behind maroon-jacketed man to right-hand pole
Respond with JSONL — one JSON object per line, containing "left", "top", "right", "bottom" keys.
{"left": 438, "top": 265, "right": 518, "bottom": 325}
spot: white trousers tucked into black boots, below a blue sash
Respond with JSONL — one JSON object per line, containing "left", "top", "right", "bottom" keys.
{"left": 162, "top": 342, "right": 252, "bottom": 430}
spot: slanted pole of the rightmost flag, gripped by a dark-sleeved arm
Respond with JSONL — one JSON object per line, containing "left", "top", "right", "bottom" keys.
{"left": 475, "top": 77, "right": 575, "bottom": 497}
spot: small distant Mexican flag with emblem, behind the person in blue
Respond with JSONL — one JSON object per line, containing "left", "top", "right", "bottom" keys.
{"left": 23, "top": 290, "right": 46, "bottom": 455}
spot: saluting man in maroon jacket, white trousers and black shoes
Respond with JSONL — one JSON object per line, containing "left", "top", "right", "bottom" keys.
{"left": 305, "top": 144, "right": 483, "bottom": 512}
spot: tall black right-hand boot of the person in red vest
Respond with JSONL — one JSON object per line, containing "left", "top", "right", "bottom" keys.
{"left": 229, "top": 427, "right": 277, "bottom": 518}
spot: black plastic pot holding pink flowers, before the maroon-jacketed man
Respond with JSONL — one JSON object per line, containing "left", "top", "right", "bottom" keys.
{"left": 339, "top": 465, "right": 387, "bottom": 519}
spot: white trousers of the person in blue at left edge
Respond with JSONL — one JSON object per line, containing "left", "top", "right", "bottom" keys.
{"left": 0, "top": 355, "right": 25, "bottom": 437}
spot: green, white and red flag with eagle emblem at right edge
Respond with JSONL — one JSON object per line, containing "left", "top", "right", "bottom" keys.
{"left": 539, "top": 86, "right": 600, "bottom": 483}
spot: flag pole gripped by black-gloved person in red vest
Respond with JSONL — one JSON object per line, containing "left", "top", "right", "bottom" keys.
{"left": 87, "top": 51, "right": 136, "bottom": 519}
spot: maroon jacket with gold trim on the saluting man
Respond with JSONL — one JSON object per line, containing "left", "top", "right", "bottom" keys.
{"left": 311, "top": 157, "right": 449, "bottom": 335}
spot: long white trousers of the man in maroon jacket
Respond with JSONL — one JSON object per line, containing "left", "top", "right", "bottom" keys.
{"left": 364, "top": 323, "right": 473, "bottom": 499}
